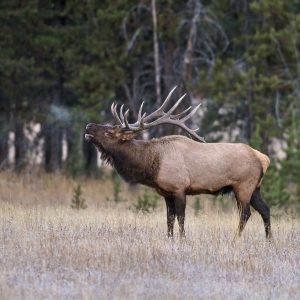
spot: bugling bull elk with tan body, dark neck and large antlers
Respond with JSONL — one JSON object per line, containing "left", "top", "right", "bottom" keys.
{"left": 85, "top": 88, "right": 271, "bottom": 238}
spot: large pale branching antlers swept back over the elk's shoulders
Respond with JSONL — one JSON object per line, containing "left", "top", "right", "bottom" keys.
{"left": 111, "top": 86, "right": 205, "bottom": 143}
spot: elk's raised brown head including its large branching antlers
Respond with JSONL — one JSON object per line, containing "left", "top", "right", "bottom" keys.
{"left": 85, "top": 87, "right": 205, "bottom": 151}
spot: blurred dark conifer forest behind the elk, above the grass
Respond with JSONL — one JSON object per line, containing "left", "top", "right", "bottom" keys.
{"left": 0, "top": 0, "right": 300, "bottom": 211}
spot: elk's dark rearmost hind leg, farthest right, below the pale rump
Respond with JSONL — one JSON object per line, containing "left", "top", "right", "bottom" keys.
{"left": 250, "top": 188, "right": 272, "bottom": 239}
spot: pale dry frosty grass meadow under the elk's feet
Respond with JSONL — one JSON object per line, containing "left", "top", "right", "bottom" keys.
{"left": 0, "top": 174, "right": 300, "bottom": 299}
